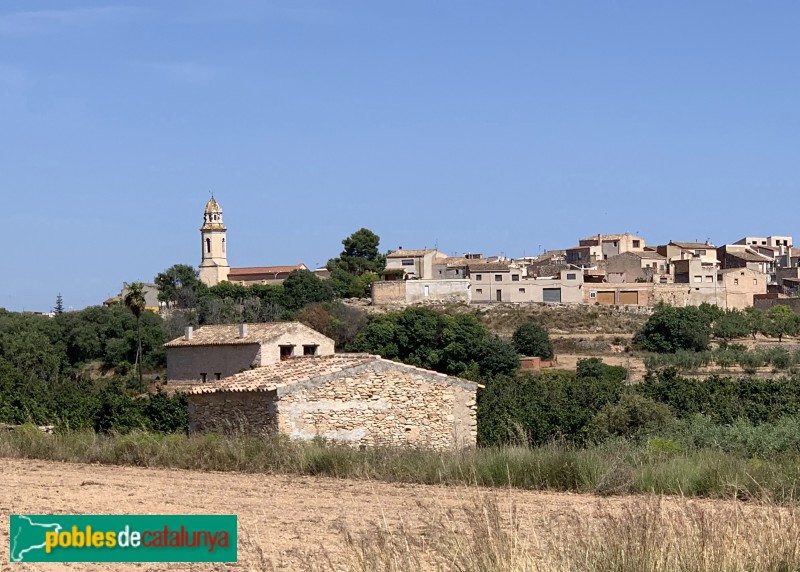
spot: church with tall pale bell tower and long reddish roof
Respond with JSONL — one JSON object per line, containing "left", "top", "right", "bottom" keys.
{"left": 199, "top": 196, "right": 308, "bottom": 286}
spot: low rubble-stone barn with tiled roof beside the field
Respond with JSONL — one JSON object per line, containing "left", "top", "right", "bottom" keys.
{"left": 186, "top": 354, "right": 479, "bottom": 450}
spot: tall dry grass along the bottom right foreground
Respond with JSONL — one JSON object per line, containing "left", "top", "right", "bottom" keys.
{"left": 309, "top": 492, "right": 800, "bottom": 572}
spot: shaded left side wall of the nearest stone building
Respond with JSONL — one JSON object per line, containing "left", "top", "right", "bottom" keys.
{"left": 188, "top": 391, "right": 277, "bottom": 433}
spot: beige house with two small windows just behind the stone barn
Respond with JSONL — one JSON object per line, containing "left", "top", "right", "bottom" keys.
{"left": 164, "top": 322, "right": 334, "bottom": 384}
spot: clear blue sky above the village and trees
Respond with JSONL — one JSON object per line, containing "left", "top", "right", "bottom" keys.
{"left": 0, "top": 0, "right": 800, "bottom": 310}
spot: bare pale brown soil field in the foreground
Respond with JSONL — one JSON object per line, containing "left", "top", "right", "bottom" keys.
{"left": 0, "top": 459, "right": 784, "bottom": 572}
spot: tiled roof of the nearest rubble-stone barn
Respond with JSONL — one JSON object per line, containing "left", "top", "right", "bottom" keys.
{"left": 186, "top": 354, "right": 479, "bottom": 394}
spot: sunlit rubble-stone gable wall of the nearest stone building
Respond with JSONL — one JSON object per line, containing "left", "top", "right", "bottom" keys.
{"left": 278, "top": 368, "right": 477, "bottom": 450}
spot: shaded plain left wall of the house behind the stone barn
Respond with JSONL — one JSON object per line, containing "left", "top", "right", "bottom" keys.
{"left": 167, "top": 344, "right": 261, "bottom": 383}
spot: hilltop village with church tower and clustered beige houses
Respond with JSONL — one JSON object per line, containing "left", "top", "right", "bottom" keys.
{"left": 191, "top": 197, "right": 800, "bottom": 310}
